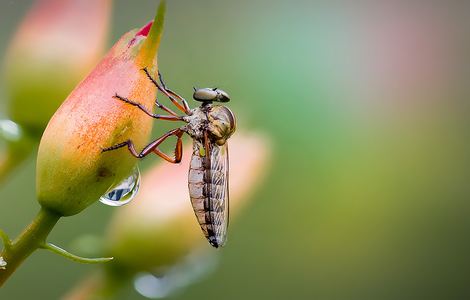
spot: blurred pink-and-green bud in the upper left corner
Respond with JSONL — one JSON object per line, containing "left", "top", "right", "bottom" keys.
{"left": 0, "top": 0, "right": 111, "bottom": 183}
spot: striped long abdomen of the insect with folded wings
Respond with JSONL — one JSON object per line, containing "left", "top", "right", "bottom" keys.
{"left": 188, "top": 140, "right": 228, "bottom": 248}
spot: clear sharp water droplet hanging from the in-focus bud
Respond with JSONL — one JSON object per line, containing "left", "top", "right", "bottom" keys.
{"left": 100, "top": 166, "right": 140, "bottom": 206}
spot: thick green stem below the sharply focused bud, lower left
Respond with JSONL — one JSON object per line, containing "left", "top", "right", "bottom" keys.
{"left": 0, "top": 209, "right": 60, "bottom": 287}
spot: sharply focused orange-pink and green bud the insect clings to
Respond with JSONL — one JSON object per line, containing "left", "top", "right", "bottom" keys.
{"left": 37, "top": 2, "right": 164, "bottom": 216}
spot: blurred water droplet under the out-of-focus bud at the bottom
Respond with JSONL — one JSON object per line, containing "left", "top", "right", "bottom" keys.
{"left": 134, "top": 250, "right": 218, "bottom": 299}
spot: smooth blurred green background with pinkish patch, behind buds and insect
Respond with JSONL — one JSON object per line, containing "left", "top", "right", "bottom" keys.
{"left": 0, "top": 0, "right": 470, "bottom": 299}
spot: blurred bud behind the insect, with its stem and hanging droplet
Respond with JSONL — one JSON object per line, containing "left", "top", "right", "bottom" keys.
{"left": 66, "top": 132, "right": 271, "bottom": 300}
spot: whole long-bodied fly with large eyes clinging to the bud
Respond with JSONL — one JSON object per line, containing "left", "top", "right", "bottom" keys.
{"left": 103, "top": 68, "right": 236, "bottom": 248}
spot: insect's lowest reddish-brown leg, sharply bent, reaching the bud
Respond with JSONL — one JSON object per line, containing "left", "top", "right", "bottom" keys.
{"left": 102, "top": 128, "right": 184, "bottom": 164}
